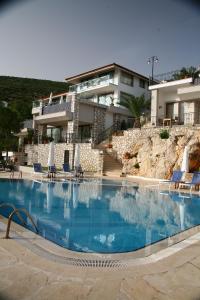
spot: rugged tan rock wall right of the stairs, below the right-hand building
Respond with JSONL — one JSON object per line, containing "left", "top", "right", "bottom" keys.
{"left": 112, "top": 126, "right": 200, "bottom": 178}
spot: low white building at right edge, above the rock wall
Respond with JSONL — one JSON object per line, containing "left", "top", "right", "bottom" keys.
{"left": 149, "top": 77, "right": 200, "bottom": 126}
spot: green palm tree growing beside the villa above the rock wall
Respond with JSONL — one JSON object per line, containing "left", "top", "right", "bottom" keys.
{"left": 119, "top": 94, "right": 151, "bottom": 127}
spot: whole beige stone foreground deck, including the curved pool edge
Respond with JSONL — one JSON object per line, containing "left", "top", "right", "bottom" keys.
{"left": 0, "top": 174, "right": 200, "bottom": 300}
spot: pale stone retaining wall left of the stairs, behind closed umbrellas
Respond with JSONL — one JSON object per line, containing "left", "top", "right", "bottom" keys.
{"left": 25, "top": 143, "right": 103, "bottom": 173}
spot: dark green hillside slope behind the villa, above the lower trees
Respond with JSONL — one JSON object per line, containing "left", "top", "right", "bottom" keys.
{"left": 0, "top": 76, "right": 68, "bottom": 121}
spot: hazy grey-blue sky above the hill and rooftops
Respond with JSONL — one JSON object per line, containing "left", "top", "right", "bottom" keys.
{"left": 0, "top": 0, "right": 200, "bottom": 81}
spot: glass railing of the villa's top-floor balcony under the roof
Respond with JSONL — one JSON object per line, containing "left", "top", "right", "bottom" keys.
{"left": 69, "top": 75, "right": 113, "bottom": 93}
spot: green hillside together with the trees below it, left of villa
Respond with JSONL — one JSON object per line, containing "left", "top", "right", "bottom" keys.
{"left": 0, "top": 76, "right": 68, "bottom": 151}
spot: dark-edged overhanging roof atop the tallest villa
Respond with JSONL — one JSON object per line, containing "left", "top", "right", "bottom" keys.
{"left": 65, "top": 63, "right": 149, "bottom": 82}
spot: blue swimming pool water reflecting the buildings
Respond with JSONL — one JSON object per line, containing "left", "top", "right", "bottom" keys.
{"left": 0, "top": 179, "right": 200, "bottom": 253}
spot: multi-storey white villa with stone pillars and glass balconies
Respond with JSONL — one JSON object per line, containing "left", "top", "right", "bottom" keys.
{"left": 18, "top": 63, "right": 149, "bottom": 169}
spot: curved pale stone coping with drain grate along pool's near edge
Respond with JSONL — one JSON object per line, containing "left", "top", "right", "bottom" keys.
{"left": 0, "top": 212, "right": 200, "bottom": 268}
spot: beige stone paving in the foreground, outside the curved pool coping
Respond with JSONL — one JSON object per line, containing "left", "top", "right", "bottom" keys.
{"left": 0, "top": 226, "right": 200, "bottom": 300}
